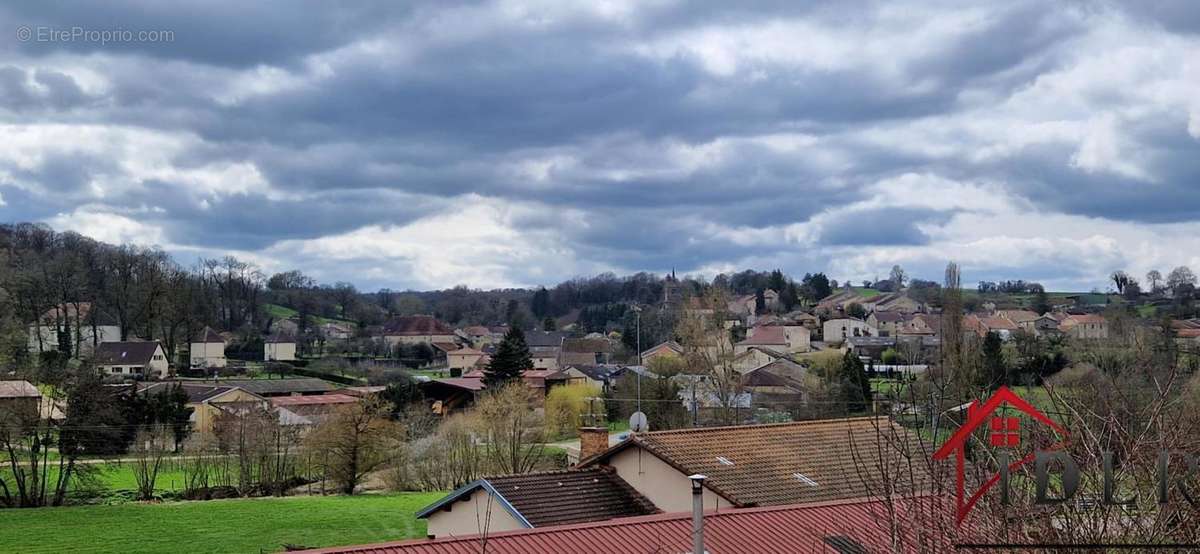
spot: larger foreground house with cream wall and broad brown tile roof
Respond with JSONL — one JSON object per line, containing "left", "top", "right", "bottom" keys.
{"left": 578, "top": 417, "right": 931, "bottom": 512}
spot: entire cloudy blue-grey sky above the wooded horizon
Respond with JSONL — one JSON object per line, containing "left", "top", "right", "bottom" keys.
{"left": 0, "top": 0, "right": 1200, "bottom": 290}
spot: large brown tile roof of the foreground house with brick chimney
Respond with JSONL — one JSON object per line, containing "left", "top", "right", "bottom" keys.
{"left": 580, "top": 417, "right": 930, "bottom": 507}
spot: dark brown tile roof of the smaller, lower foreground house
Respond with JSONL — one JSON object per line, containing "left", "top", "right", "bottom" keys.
{"left": 418, "top": 468, "right": 659, "bottom": 528}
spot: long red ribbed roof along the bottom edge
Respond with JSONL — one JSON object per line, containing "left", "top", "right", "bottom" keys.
{"left": 297, "top": 499, "right": 953, "bottom": 554}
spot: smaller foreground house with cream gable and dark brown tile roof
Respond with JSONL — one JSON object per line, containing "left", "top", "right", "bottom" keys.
{"left": 416, "top": 466, "right": 659, "bottom": 538}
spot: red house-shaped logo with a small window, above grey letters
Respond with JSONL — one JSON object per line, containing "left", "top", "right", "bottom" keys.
{"left": 934, "top": 386, "right": 1068, "bottom": 524}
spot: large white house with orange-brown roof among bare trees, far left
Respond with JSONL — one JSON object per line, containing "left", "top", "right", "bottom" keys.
{"left": 29, "top": 302, "right": 121, "bottom": 357}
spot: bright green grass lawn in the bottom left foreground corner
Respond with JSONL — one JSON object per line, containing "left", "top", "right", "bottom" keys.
{"left": 0, "top": 493, "right": 443, "bottom": 554}
